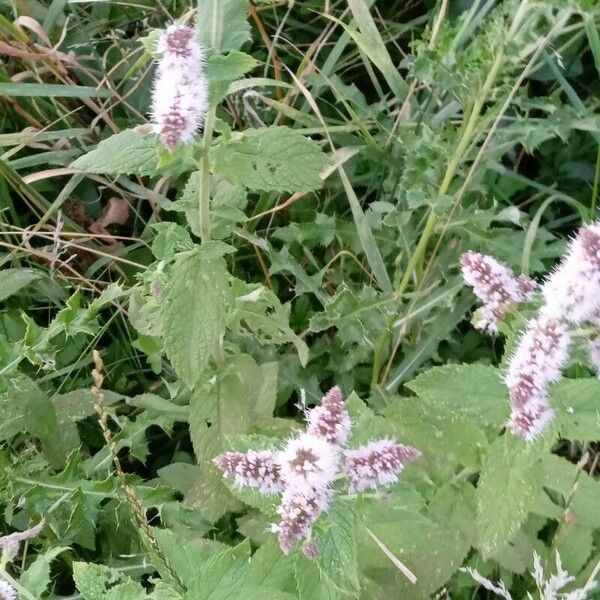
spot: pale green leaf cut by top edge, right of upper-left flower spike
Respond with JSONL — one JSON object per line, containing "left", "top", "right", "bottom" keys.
{"left": 196, "top": 0, "right": 250, "bottom": 52}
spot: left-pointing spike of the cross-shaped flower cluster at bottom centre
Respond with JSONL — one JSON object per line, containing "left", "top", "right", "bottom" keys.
{"left": 213, "top": 450, "right": 283, "bottom": 494}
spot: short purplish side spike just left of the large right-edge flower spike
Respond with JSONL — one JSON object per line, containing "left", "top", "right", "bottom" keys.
{"left": 460, "top": 251, "right": 537, "bottom": 333}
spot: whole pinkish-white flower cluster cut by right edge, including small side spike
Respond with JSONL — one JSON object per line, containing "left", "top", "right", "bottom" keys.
{"left": 461, "top": 222, "right": 600, "bottom": 441}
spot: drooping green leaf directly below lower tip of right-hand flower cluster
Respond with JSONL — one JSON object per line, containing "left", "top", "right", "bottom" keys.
{"left": 476, "top": 435, "right": 543, "bottom": 557}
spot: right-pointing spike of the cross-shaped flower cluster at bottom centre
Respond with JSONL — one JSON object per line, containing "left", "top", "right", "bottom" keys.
{"left": 344, "top": 440, "right": 421, "bottom": 492}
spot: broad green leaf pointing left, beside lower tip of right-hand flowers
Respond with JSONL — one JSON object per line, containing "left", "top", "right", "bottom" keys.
{"left": 405, "top": 364, "right": 509, "bottom": 427}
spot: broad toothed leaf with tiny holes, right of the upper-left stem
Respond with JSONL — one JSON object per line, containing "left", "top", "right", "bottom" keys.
{"left": 210, "top": 127, "right": 327, "bottom": 192}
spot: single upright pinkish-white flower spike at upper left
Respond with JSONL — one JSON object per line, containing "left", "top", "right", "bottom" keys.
{"left": 152, "top": 24, "right": 208, "bottom": 150}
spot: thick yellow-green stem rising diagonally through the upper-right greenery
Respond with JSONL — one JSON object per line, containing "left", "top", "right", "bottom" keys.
{"left": 371, "top": 48, "right": 504, "bottom": 387}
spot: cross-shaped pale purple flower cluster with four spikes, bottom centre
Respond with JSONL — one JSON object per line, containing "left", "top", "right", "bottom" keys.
{"left": 213, "top": 387, "right": 420, "bottom": 559}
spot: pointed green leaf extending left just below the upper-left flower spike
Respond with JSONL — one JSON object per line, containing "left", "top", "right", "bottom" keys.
{"left": 71, "top": 129, "right": 158, "bottom": 175}
